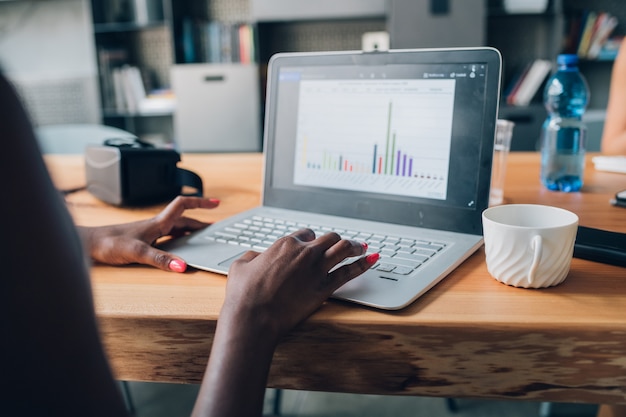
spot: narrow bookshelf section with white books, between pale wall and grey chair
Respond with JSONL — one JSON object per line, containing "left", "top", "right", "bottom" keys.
{"left": 91, "top": 0, "right": 173, "bottom": 142}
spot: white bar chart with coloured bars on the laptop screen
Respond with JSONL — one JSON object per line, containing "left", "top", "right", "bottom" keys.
{"left": 294, "top": 79, "right": 455, "bottom": 199}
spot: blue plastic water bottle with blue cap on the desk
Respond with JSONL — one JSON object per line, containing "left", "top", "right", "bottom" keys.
{"left": 541, "top": 54, "right": 589, "bottom": 192}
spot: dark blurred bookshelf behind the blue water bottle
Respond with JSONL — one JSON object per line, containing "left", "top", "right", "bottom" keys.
{"left": 487, "top": 0, "right": 626, "bottom": 150}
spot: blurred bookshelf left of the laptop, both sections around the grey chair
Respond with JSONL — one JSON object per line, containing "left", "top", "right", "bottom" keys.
{"left": 91, "top": 0, "right": 260, "bottom": 150}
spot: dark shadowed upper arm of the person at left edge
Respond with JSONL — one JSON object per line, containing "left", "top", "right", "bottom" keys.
{"left": 0, "top": 71, "right": 126, "bottom": 417}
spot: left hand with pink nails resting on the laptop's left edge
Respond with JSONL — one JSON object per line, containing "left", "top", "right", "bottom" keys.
{"left": 79, "top": 196, "right": 219, "bottom": 272}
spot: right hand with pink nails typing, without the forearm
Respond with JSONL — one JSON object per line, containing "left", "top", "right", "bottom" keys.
{"left": 220, "top": 229, "right": 378, "bottom": 338}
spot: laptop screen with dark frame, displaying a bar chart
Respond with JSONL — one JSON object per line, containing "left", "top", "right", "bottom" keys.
{"left": 264, "top": 48, "right": 500, "bottom": 236}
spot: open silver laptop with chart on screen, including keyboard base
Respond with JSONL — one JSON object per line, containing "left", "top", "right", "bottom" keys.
{"left": 164, "top": 47, "right": 501, "bottom": 310}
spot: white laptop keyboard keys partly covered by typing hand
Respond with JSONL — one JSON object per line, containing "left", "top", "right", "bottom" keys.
{"left": 206, "top": 216, "right": 446, "bottom": 275}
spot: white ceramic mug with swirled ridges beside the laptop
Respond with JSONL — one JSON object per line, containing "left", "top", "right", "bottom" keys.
{"left": 482, "top": 204, "right": 578, "bottom": 288}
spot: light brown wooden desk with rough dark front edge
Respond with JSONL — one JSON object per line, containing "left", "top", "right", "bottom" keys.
{"left": 48, "top": 153, "right": 626, "bottom": 404}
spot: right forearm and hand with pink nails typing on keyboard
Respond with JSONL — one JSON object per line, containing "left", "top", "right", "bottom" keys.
{"left": 193, "top": 229, "right": 378, "bottom": 417}
